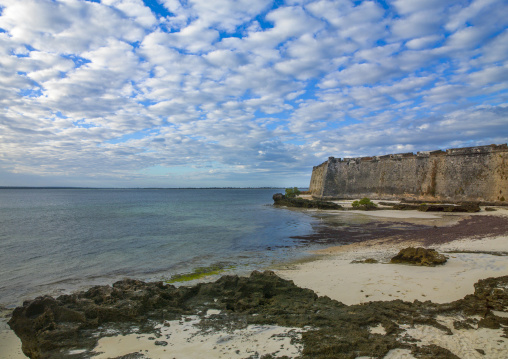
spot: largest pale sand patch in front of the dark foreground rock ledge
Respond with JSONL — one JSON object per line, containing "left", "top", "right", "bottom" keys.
{"left": 94, "top": 316, "right": 302, "bottom": 359}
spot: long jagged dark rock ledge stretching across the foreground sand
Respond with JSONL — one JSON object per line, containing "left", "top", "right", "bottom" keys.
{"left": 9, "top": 271, "right": 508, "bottom": 359}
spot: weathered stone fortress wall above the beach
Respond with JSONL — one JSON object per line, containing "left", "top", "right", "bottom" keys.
{"left": 309, "top": 144, "right": 508, "bottom": 204}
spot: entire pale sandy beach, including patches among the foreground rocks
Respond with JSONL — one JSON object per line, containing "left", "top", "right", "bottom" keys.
{"left": 0, "top": 202, "right": 508, "bottom": 359}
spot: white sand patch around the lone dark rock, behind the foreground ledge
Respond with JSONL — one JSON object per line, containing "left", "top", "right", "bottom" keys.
{"left": 277, "top": 236, "right": 508, "bottom": 305}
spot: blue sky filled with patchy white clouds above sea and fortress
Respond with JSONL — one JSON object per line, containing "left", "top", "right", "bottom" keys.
{"left": 0, "top": 0, "right": 508, "bottom": 187}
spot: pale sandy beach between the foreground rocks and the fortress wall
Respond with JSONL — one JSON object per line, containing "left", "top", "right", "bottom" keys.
{"left": 277, "top": 205, "right": 508, "bottom": 305}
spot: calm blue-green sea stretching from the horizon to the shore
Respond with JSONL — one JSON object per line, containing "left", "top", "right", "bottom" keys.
{"left": 0, "top": 189, "right": 315, "bottom": 307}
